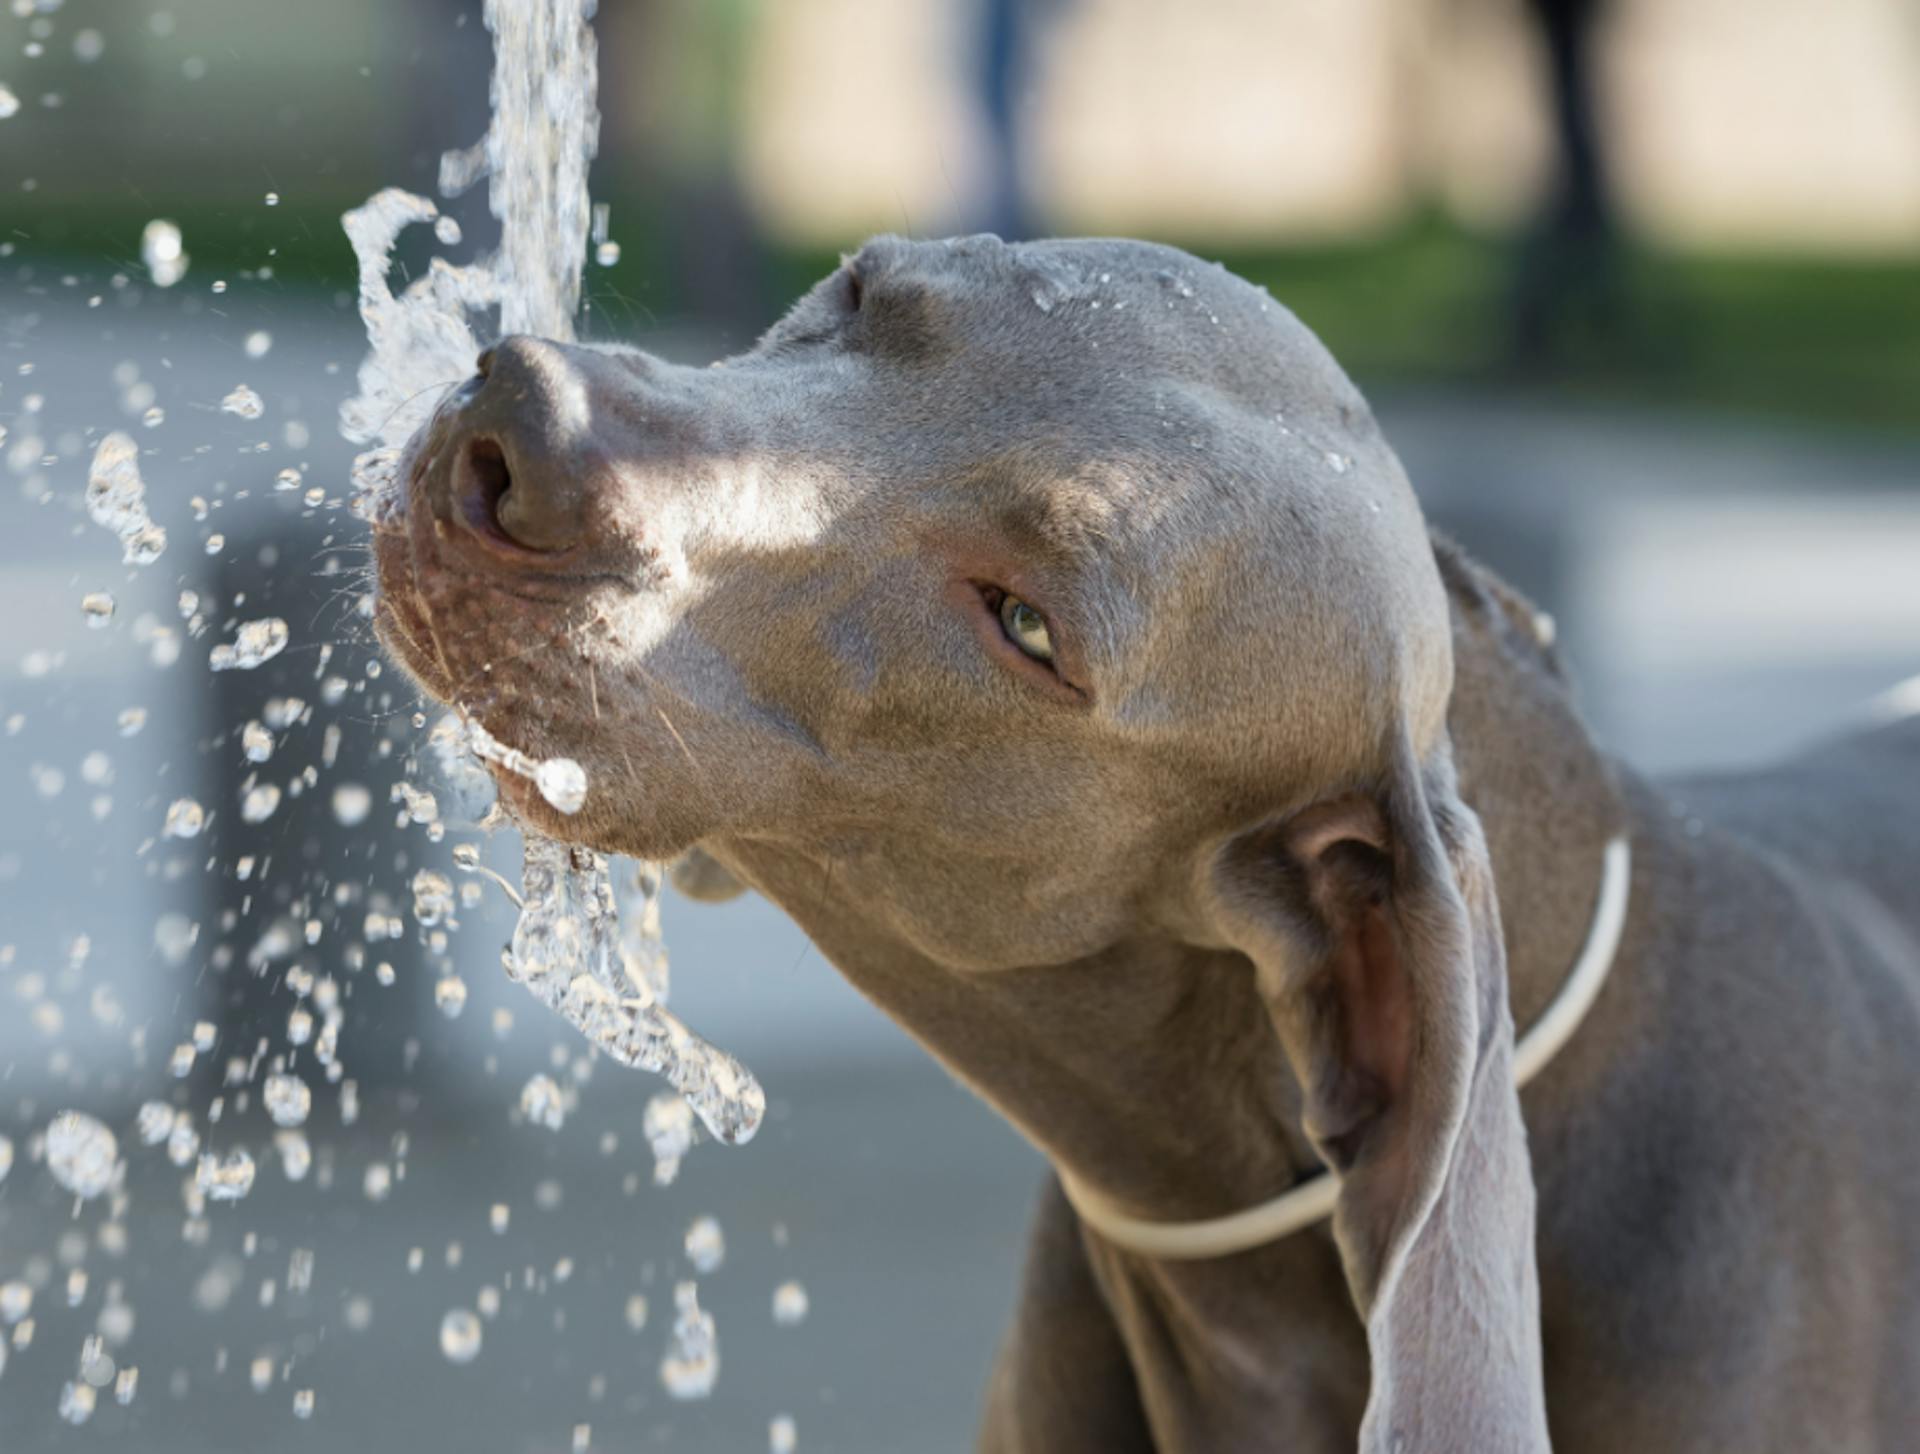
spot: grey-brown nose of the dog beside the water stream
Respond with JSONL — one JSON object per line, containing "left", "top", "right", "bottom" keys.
{"left": 453, "top": 336, "right": 593, "bottom": 553}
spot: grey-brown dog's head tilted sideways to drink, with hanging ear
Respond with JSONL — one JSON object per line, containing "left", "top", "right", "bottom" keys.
{"left": 378, "top": 238, "right": 1530, "bottom": 1444}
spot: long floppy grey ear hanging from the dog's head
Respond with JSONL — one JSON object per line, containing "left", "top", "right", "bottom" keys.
{"left": 1212, "top": 739, "right": 1548, "bottom": 1454}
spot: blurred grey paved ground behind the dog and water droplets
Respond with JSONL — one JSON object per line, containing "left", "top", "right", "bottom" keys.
{"left": 0, "top": 290, "right": 1920, "bottom": 1454}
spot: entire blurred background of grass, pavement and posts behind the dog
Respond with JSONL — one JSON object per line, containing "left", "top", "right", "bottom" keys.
{"left": 0, "top": 0, "right": 1920, "bottom": 1454}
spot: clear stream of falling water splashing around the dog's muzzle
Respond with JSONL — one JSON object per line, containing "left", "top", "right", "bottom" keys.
{"left": 342, "top": 0, "right": 766, "bottom": 1143}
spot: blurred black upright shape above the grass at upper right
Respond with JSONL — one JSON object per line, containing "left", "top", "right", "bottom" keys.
{"left": 1511, "top": 0, "right": 1619, "bottom": 367}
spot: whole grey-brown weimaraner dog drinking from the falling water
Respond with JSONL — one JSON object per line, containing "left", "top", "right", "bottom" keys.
{"left": 376, "top": 238, "right": 1920, "bottom": 1454}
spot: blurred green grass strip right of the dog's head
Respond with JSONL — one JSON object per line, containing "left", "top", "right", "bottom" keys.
{"left": 1221, "top": 227, "right": 1920, "bottom": 430}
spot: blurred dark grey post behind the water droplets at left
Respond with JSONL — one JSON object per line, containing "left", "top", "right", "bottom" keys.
{"left": 198, "top": 513, "right": 432, "bottom": 1097}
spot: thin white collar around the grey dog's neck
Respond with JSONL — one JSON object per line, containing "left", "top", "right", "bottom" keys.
{"left": 1056, "top": 836, "right": 1632, "bottom": 1260}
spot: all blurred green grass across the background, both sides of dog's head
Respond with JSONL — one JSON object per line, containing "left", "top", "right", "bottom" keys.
{"left": 18, "top": 201, "right": 1920, "bottom": 430}
